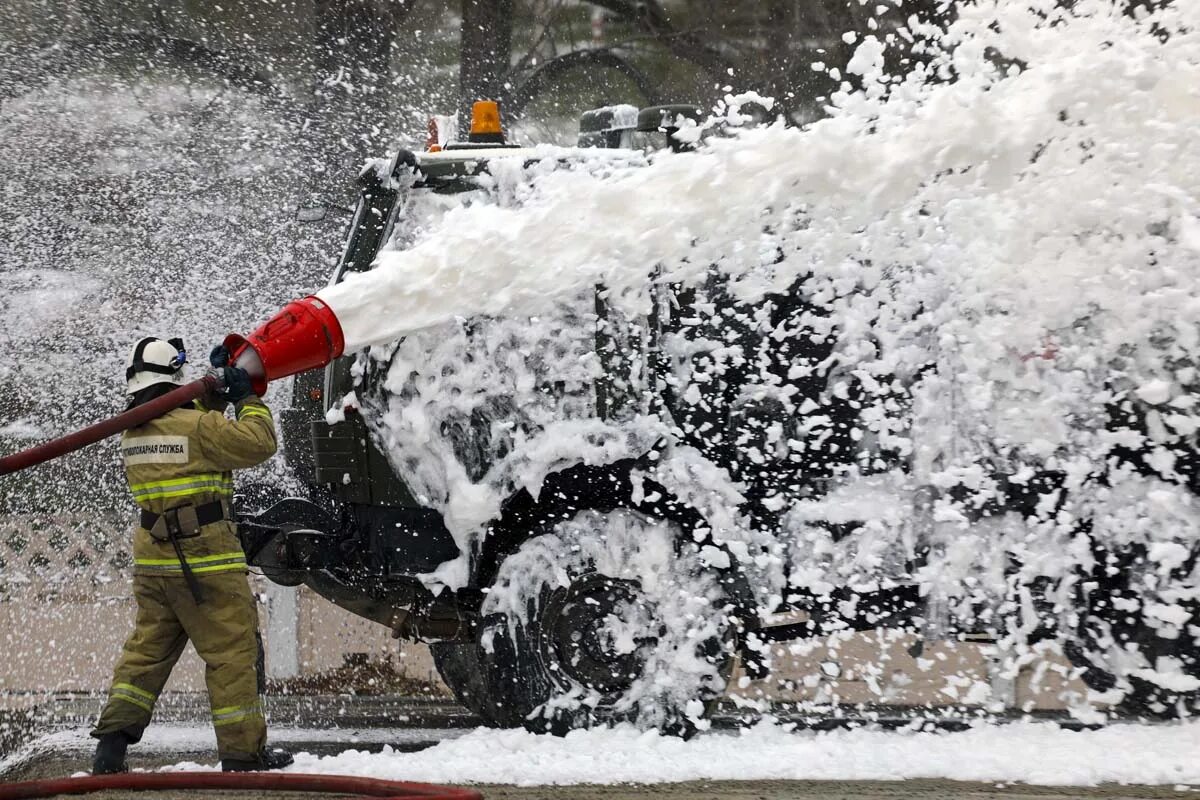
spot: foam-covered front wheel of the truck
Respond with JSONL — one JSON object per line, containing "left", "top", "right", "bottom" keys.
{"left": 476, "top": 509, "right": 734, "bottom": 738}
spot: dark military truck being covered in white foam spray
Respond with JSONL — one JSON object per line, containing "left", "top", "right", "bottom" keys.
{"left": 241, "top": 106, "right": 1200, "bottom": 735}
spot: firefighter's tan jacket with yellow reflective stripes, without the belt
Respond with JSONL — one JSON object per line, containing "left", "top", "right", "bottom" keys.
{"left": 121, "top": 396, "right": 276, "bottom": 576}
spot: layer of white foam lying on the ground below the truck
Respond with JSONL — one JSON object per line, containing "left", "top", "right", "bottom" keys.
{"left": 272, "top": 723, "right": 1200, "bottom": 786}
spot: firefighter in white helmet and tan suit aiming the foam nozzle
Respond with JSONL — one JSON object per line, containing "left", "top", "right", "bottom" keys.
{"left": 91, "top": 337, "right": 292, "bottom": 775}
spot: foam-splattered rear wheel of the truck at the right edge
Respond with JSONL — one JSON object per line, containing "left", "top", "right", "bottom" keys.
{"left": 1063, "top": 537, "right": 1200, "bottom": 720}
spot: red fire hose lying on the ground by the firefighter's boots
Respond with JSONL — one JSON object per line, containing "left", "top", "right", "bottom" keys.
{"left": 0, "top": 772, "right": 482, "bottom": 800}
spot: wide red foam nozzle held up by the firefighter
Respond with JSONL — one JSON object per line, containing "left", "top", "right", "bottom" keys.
{"left": 224, "top": 295, "right": 346, "bottom": 395}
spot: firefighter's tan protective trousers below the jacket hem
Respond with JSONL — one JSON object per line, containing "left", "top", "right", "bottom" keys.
{"left": 92, "top": 571, "right": 266, "bottom": 760}
